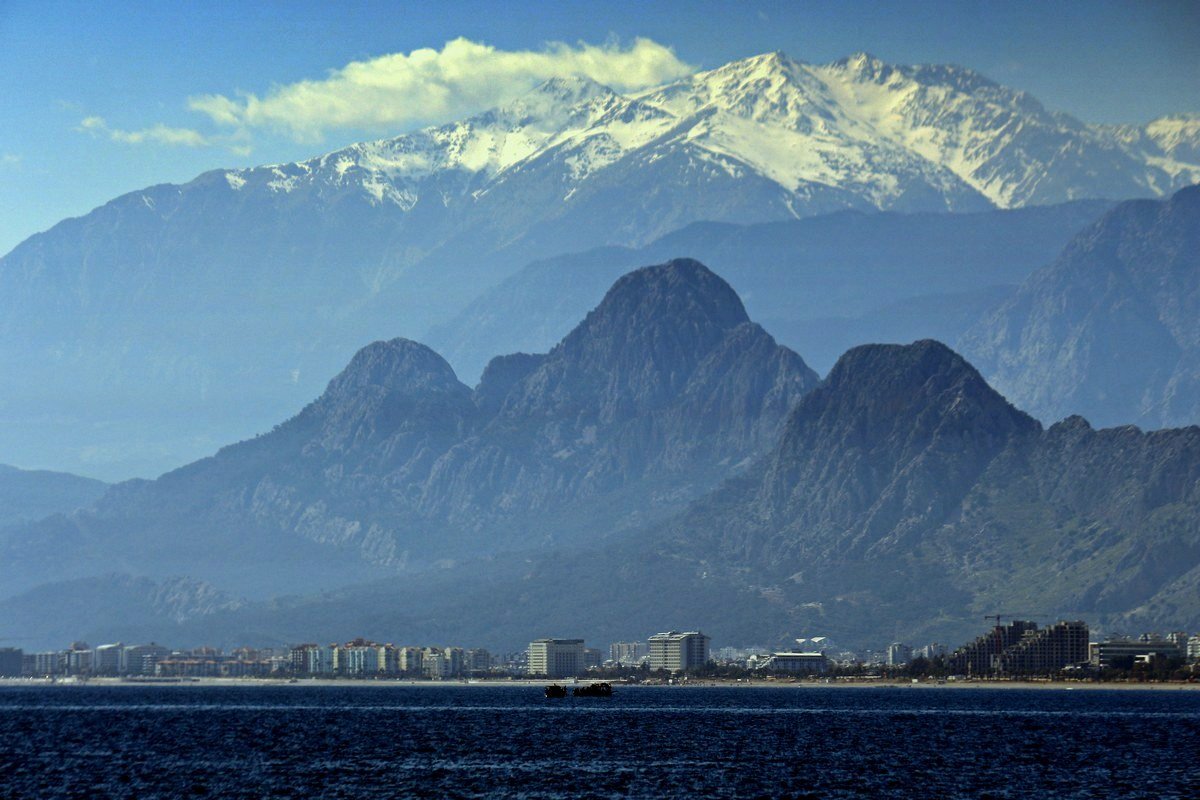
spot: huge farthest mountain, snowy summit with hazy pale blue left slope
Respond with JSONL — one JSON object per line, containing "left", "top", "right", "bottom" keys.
{"left": 0, "top": 54, "right": 1200, "bottom": 476}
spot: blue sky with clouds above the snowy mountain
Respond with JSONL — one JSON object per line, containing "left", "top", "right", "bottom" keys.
{"left": 0, "top": 0, "right": 1200, "bottom": 253}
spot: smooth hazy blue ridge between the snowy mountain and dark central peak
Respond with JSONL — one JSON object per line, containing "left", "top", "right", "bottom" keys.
{"left": 426, "top": 200, "right": 1114, "bottom": 375}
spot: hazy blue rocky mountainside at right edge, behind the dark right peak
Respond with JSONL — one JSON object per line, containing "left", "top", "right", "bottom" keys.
{"left": 962, "top": 186, "right": 1200, "bottom": 428}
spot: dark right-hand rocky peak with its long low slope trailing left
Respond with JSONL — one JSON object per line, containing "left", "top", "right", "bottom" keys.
{"left": 37, "top": 342, "right": 1200, "bottom": 648}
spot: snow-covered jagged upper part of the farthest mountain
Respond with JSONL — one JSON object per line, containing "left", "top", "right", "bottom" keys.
{"left": 226, "top": 53, "right": 1200, "bottom": 216}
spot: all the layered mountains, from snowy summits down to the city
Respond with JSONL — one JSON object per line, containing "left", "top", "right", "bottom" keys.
{"left": 0, "top": 42, "right": 1200, "bottom": 648}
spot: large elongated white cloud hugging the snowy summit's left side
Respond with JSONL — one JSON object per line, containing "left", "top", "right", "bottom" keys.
{"left": 186, "top": 38, "right": 692, "bottom": 140}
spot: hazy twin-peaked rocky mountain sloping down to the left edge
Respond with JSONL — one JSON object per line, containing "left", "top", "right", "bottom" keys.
{"left": 0, "top": 260, "right": 817, "bottom": 604}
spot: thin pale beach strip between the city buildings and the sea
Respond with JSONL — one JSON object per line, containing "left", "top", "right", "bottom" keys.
{"left": 0, "top": 678, "right": 1200, "bottom": 692}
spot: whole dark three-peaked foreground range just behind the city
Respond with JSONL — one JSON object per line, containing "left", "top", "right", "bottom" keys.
{"left": 0, "top": 262, "right": 1200, "bottom": 646}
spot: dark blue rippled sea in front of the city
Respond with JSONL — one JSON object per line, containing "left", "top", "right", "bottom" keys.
{"left": 0, "top": 685, "right": 1200, "bottom": 800}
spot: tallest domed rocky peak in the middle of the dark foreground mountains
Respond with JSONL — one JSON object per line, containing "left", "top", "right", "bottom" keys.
{"left": 424, "top": 260, "right": 817, "bottom": 539}
